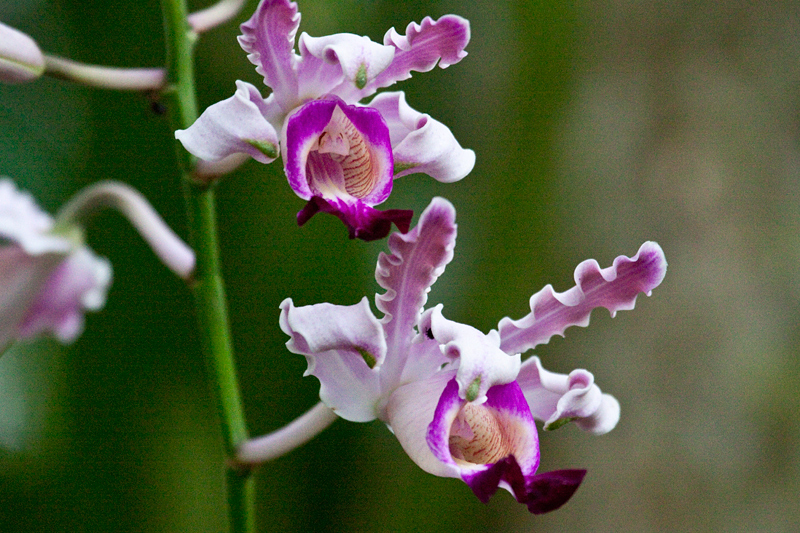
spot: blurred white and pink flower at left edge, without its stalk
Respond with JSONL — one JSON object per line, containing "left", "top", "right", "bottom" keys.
{"left": 0, "top": 178, "right": 111, "bottom": 351}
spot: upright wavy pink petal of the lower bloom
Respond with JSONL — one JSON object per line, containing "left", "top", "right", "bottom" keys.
{"left": 375, "top": 197, "right": 457, "bottom": 383}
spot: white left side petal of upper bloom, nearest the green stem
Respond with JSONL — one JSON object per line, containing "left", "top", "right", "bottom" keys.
{"left": 175, "top": 81, "right": 279, "bottom": 163}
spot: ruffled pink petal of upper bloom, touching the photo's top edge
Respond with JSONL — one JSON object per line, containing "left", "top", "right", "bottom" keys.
{"left": 239, "top": 0, "right": 300, "bottom": 113}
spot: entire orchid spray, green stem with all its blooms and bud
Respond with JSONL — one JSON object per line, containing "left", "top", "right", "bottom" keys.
{"left": 0, "top": 0, "right": 666, "bottom": 531}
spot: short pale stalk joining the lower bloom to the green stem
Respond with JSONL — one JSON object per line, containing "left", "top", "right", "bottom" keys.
{"left": 235, "top": 402, "right": 338, "bottom": 467}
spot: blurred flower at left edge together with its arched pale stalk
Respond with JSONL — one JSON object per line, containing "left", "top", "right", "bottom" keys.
{"left": 0, "top": 178, "right": 194, "bottom": 353}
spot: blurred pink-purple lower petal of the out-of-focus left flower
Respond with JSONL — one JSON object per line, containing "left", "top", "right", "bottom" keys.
{"left": 19, "top": 246, "right": 111, "bottom": 343}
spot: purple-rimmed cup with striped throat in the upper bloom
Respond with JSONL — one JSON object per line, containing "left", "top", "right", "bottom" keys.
{"left": 282, "top": 99, "right": 393, "bottom": 206}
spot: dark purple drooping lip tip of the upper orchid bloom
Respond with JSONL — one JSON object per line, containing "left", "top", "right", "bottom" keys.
{"left": 297, "top": 196, "right": 414, "bottom": 241}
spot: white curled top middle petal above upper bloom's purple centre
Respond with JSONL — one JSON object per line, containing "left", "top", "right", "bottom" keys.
{"left": 298, "top": 33, "right": 395, "bottom": 96}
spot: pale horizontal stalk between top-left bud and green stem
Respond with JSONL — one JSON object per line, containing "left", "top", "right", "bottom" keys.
{"left": 44, "top": 54, "right": 166, "bottom": 91}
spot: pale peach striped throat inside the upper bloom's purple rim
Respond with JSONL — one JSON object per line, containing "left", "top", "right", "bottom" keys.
{"left": 312, "top": 106, "right": 378, "bottom": 198}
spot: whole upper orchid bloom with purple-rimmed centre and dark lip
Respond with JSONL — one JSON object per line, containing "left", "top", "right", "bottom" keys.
{"left": 175, "top": 0, "right": 475, "bottom": 240}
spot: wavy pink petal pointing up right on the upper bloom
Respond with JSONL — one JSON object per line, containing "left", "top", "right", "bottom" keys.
{"left": 337, "top": 15, "right": 470, "bottom": 102}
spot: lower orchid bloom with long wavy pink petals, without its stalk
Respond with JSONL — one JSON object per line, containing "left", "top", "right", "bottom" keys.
{"left": 280, "top": 198, "right": 666, "bottom": 513}
